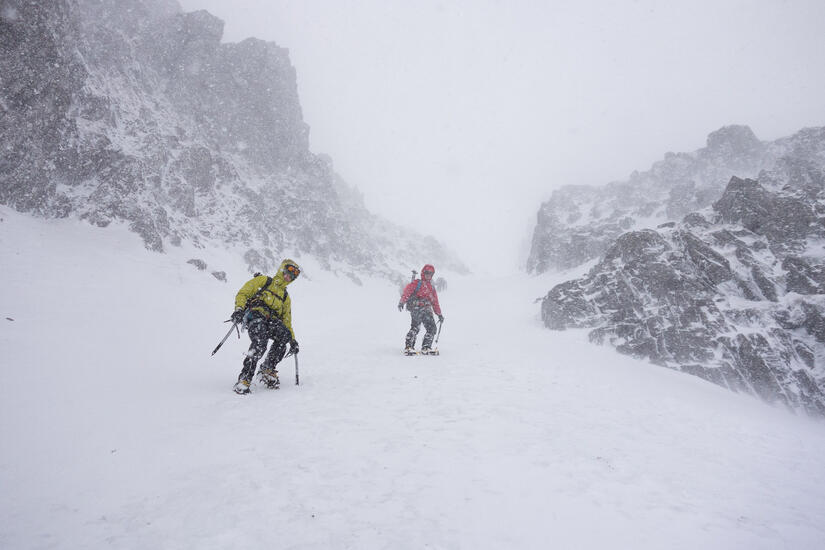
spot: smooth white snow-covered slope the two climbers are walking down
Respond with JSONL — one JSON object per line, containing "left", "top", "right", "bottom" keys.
{"left": 0, "top": 207, "right": 825, "bottom": 550}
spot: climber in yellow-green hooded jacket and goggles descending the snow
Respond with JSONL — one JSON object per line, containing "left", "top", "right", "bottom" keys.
{"left": 232, "top": 259, "right": 301, "bottom": 394}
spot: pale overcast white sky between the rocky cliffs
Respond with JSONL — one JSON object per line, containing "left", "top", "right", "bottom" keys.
{"left": 179, "top": 0, "right": 825, "bottom": 271}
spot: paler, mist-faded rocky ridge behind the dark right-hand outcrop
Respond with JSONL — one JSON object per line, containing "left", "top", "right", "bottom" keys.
{"left": 527, "top": 126, "right": 818, "bottom": 273}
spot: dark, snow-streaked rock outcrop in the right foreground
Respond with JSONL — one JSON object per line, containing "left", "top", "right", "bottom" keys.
{"left": 542, "top": 153, "right": 825, "bottom": 414}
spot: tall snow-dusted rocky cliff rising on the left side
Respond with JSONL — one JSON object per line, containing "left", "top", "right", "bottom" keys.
{"left": 0, "top": 0, "right": 463, "bottom": 276}
